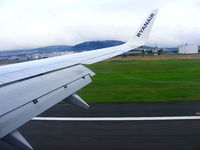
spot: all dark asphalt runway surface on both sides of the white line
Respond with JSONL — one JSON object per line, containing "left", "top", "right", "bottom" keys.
{"left": 0, "top": 102, "right": 200, "bottom": 150}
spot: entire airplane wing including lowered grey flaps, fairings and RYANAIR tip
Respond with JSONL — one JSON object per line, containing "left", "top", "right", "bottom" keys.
{"left": 0, "top": 10, "right": 158, "bottom": 150}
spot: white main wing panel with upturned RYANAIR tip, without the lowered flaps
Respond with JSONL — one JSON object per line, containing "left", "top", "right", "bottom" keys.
{"left": 0, "top": 9, "right": 158, "bottom": 85}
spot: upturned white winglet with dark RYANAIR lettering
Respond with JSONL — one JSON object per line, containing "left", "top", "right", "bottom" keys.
{"left": 126, "top": 9, "right": 158, "bottom": 46}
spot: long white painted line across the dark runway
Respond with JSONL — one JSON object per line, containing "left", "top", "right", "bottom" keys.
{"left": 32, "top": 116, "right": 200, "bottom": 121}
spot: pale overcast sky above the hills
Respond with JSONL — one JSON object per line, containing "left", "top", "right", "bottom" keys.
{"left": 0, "top": 0, "right": 200, "bottom": 50}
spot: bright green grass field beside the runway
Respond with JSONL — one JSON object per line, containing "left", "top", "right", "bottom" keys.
{"left": 78, "top": 60, "right": 200, "bottom": 102}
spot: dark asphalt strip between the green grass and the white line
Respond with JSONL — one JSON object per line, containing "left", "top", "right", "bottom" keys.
{"left": 37, "top": 102, "right": 200, "bottom": 117}
